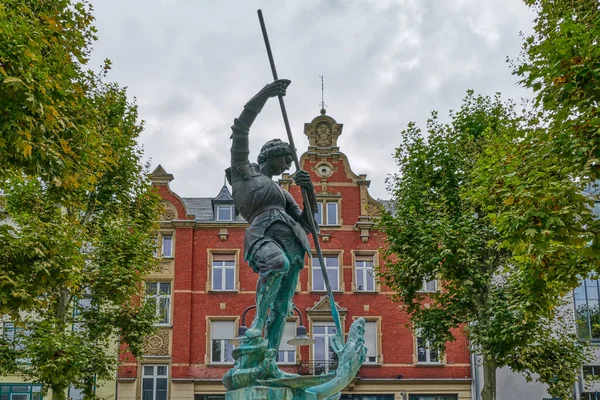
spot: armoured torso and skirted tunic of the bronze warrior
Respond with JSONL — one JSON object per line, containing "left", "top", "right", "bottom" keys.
{"left": 227, "top": 119, "right": 310, "bottom": 272}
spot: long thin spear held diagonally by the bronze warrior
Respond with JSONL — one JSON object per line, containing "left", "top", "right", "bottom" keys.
{"left": 257, "top": 10, "right": 344, "bottom": 344}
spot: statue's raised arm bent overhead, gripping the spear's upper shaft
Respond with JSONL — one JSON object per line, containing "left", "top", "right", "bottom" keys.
{"left": 231, "top": 79, "right": 290, "bottom": 181}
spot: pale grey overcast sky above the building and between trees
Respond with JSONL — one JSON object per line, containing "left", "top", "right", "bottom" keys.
{"left": 90, "top": 0, "right": 534, "bottom": 199}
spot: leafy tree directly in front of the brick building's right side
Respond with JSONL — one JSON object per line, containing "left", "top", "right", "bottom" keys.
{"left": 380, "top": 92, "right": 586, "bottom": 400}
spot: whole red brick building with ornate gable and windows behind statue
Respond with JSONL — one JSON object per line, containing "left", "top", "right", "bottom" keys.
{"left": 118, "top": 110, "right": 471, "bottom": 400}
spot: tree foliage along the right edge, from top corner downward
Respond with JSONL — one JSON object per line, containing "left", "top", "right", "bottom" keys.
{"left": 473, "top": 0, "right": 600, "bottom": 318}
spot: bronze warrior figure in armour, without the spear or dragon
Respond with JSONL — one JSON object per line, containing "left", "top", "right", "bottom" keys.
{"left": 226, "top": 79, "right": 317, "bottom": 350}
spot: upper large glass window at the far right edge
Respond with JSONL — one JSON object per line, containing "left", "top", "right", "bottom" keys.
{"left": 574, "top": 279, "right": 600, "bottom": 340}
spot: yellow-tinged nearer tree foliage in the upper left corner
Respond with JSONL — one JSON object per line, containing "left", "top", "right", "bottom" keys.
{"left": 0, "top": 0, "right": 98, "bottom": 184}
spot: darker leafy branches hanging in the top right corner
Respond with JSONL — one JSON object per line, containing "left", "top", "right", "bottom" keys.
{"left": 514, "top": 0, "right": 600, "bottom": 175}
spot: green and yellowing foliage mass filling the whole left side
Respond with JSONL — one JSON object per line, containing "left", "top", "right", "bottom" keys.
{"left": 0, "top": 0, "right": 160, "bottom": 399}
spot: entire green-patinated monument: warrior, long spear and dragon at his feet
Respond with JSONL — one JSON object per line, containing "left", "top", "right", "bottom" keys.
{"left": 222, "top": 10, "right": 367, "bottom": 400}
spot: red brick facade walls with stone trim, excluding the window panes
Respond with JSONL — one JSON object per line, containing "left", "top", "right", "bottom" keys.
{"left": 119, "top": 111, "right": 471, "bottom": 400}
